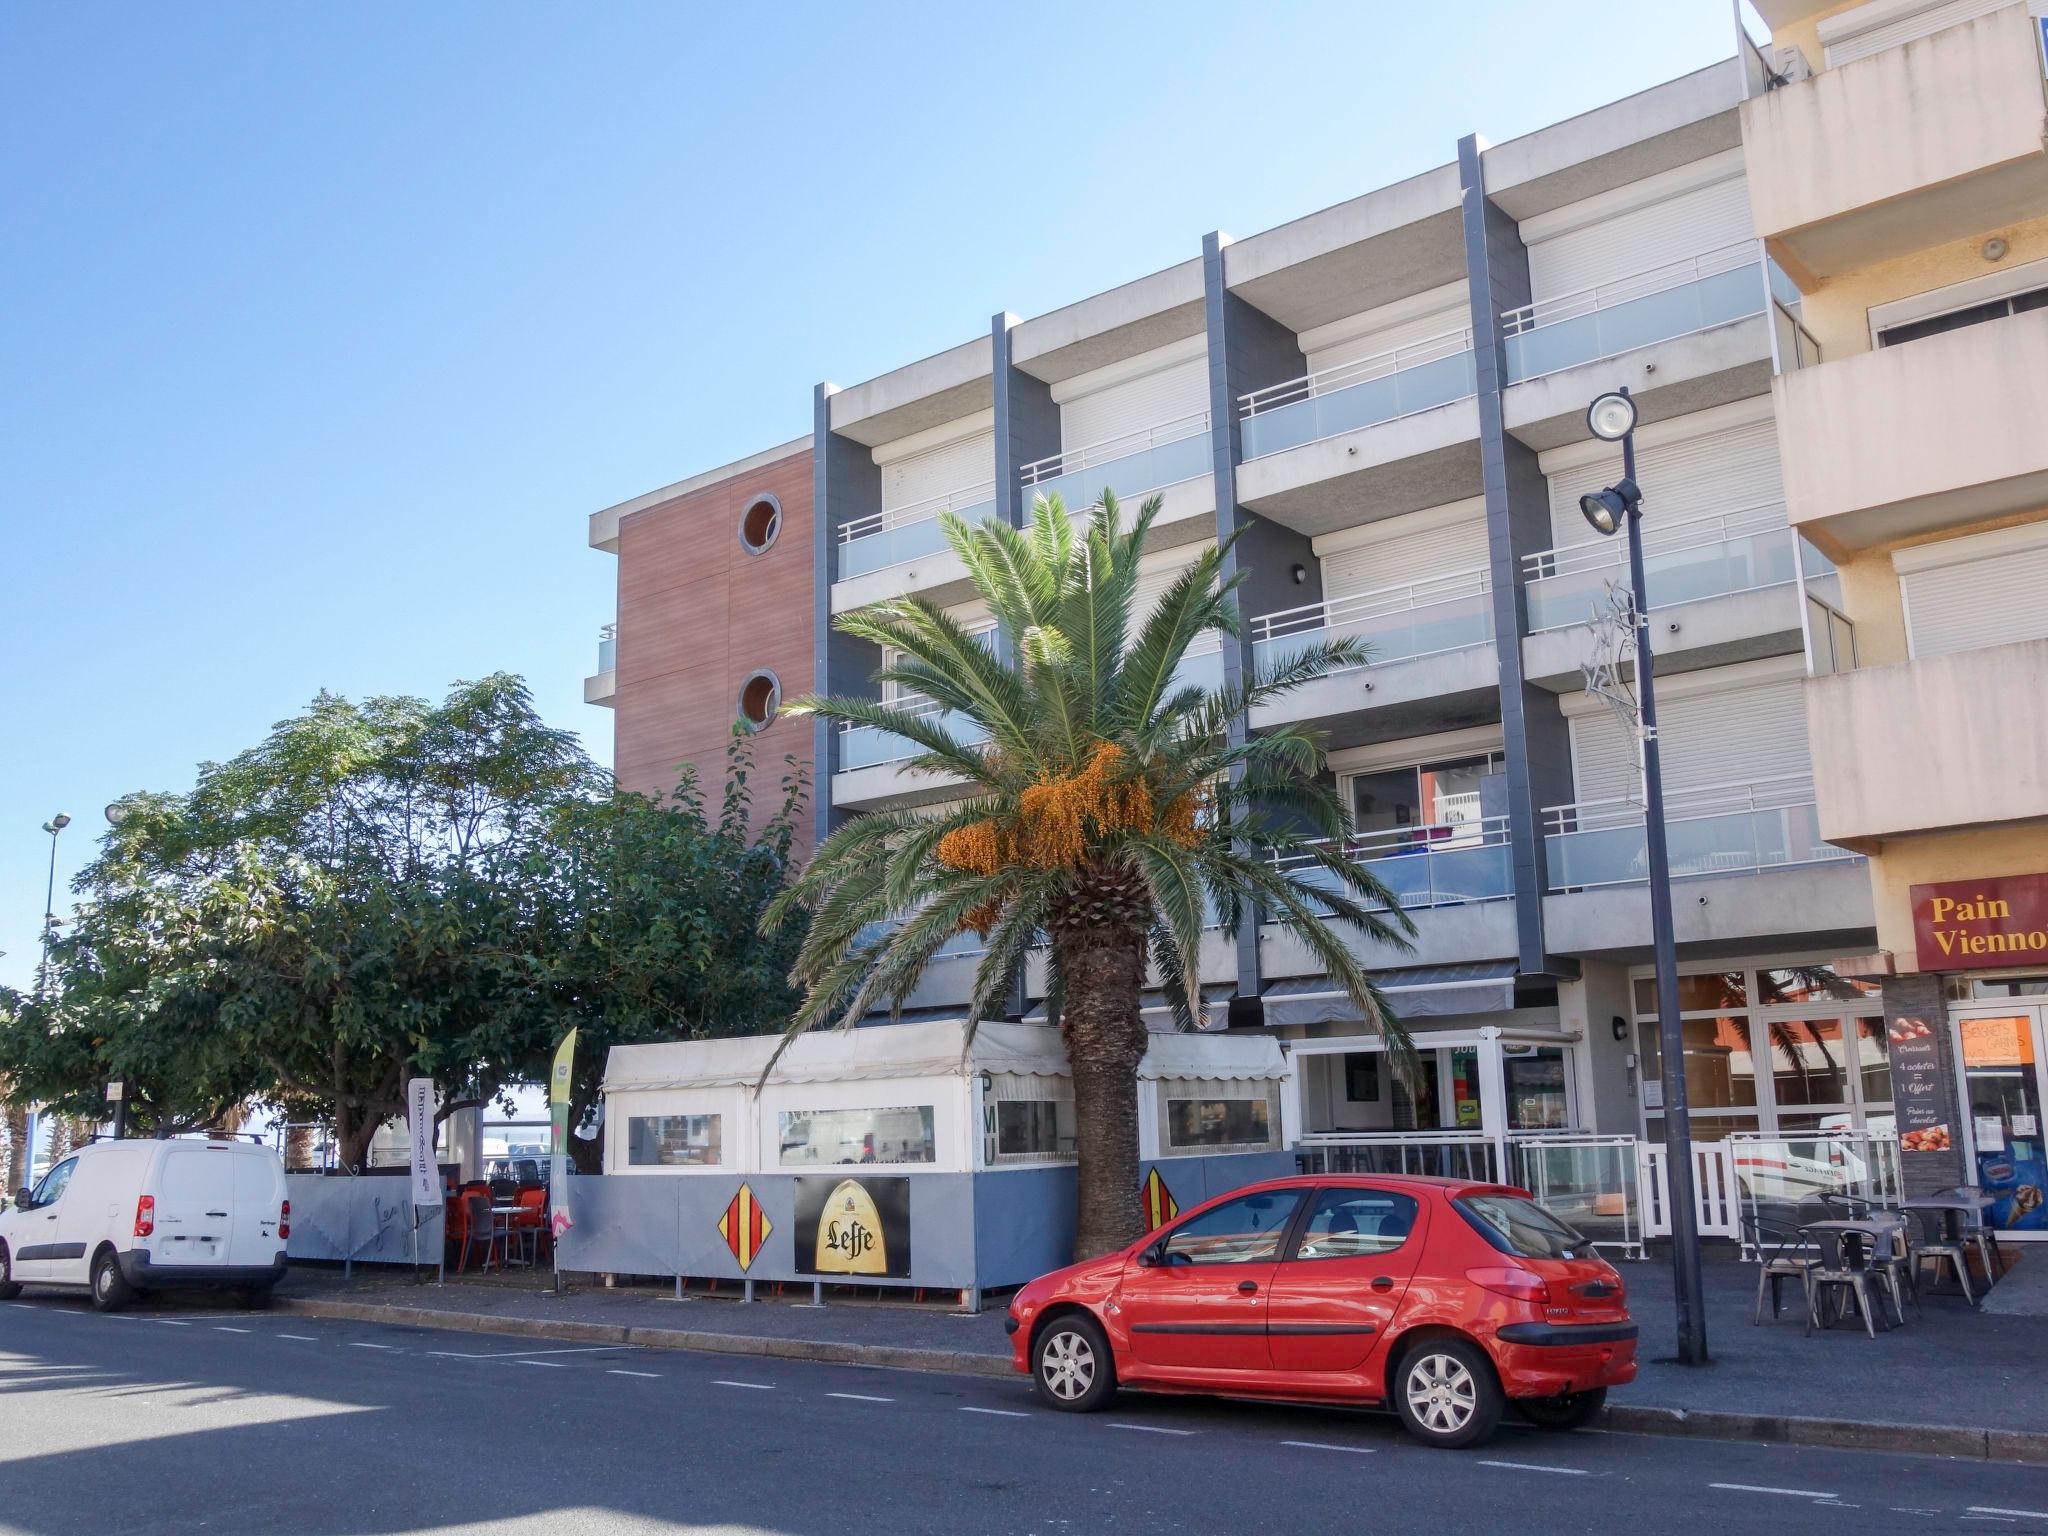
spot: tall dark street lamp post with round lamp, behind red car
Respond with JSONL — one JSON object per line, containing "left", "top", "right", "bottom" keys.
{"left": 1579, "top": 389, "right": 1708, "bottom": 1366}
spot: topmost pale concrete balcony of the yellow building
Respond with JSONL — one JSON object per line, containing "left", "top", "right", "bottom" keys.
{"left": 1741, "top": 0, "right": 2048, "bottom": 281}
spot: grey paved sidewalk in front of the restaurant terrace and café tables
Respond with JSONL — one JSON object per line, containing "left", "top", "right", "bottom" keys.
{"left": 279, "top": 1255, "right": 2048, "bottom": 1464}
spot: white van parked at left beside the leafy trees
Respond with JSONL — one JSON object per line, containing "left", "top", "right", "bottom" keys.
{"left": 0, "top": 1141, "right": 291, "bottom": 1313}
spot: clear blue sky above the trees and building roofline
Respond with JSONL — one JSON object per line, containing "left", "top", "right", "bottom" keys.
{"left": 0, "top": 0, "right": 1733, "bottom": 985}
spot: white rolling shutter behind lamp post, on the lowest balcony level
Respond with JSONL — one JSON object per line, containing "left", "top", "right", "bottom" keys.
{"left": 1571, "top": 678, "right": 1812, "bottom": 813}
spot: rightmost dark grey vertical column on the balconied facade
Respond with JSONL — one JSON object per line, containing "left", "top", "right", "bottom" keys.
{"left": 1458, "top": 135, "right": 1571, "bottom": 975}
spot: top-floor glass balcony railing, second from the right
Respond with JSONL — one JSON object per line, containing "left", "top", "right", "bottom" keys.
{"left": 1237, "top": 326, "right": 1479, "bottom": 459}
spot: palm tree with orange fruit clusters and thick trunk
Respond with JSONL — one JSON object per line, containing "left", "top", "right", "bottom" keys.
{"left": 764, "top": 492, "right": 1415, "bottom": 1257}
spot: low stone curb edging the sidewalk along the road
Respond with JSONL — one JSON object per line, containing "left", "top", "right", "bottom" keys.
{"left": 276, "top": 1296, "right": 2048, "bottom": 1466}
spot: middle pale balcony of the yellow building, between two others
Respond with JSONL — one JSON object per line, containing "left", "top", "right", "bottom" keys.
{"left": 1772, "top": 309, "right": 2048, "bottom": 559}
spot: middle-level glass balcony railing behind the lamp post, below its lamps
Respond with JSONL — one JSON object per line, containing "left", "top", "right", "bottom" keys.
{"left": 1522, "top": 502, "right": 1798, "bottom": 633}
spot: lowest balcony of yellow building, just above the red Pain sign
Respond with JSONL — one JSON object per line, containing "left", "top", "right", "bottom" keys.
{"left": 1806, "top": 641, "right": 2048, "bottom": 850}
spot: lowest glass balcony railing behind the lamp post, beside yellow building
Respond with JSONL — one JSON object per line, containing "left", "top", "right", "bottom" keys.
{"left": 1542, "top": 774, "right": 1858, "bottom": 891}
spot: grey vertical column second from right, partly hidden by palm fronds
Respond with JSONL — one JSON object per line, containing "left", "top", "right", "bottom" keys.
{"left": 1202, "top": 231, "right": 1321, "bottom": 1024}
